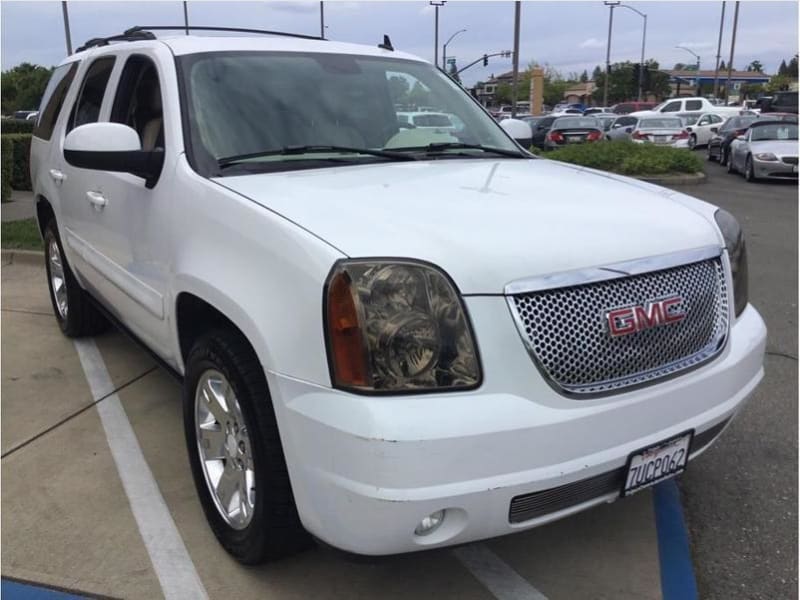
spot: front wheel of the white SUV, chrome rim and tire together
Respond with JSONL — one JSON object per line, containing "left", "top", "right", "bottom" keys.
{"left": 183, "top": 330, "right": 311, "bottom": 565}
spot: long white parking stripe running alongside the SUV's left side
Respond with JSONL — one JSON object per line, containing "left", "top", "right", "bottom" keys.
{"left": 75, "top": 339, "right": 208, "bottom": 600}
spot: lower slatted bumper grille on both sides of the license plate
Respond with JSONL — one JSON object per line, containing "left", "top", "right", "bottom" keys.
{"left": 508, "top": 418, "right": 730, "bottom": 523}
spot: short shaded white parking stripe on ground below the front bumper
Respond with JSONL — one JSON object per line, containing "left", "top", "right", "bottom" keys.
{"left": 453, "top": 544, "right": 547, "bottom": 600}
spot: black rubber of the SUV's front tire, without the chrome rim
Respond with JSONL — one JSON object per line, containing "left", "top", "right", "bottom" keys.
{"left": 183, "top": 330, "right": 311, "bottom": 565}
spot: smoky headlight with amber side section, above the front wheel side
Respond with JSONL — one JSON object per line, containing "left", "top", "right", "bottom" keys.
{"left": 324, "top": 259, "right": 480, "bottom": 392}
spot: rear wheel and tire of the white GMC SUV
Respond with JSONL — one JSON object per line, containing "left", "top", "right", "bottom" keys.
{"left": 43, "top": 219, "right": 109, "bottom": 337}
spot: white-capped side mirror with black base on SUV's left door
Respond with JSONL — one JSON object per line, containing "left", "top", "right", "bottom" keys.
{"left": 64, "top": 123, "right": 164, "bottom": 188}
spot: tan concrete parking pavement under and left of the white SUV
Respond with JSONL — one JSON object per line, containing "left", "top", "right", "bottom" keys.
{"left": 2, "top": 263, "right": 661, "bottom": 600}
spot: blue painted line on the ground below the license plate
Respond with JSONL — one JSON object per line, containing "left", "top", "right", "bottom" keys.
{"left": 653, "top": 479, "right": 698, "bottom": 600}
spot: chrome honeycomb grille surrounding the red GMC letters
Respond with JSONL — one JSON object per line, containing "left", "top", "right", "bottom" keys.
{"left": 509, "top": 257, "right": 728, "bottom": 397}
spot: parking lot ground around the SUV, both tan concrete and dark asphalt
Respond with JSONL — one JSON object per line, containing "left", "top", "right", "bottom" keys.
{"left": 2, "top": 157, "right": 797, "bottom": 599}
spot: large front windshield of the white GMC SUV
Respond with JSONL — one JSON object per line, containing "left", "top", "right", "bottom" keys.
{"left": 179, "top": 52, "right": 519, "bottom": 175}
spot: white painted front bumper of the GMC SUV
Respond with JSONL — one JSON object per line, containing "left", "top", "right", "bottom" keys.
{"left": 268, "top": 297, "right": 766, "bottom": 555}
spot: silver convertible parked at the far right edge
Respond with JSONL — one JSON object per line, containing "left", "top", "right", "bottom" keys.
{"left": 728, "top": 120, "right": 798, "bottom": 182}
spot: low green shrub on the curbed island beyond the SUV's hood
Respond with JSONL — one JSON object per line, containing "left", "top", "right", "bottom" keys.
{"left": 545, "top": 141, "right": 703, "bottom": 175}
